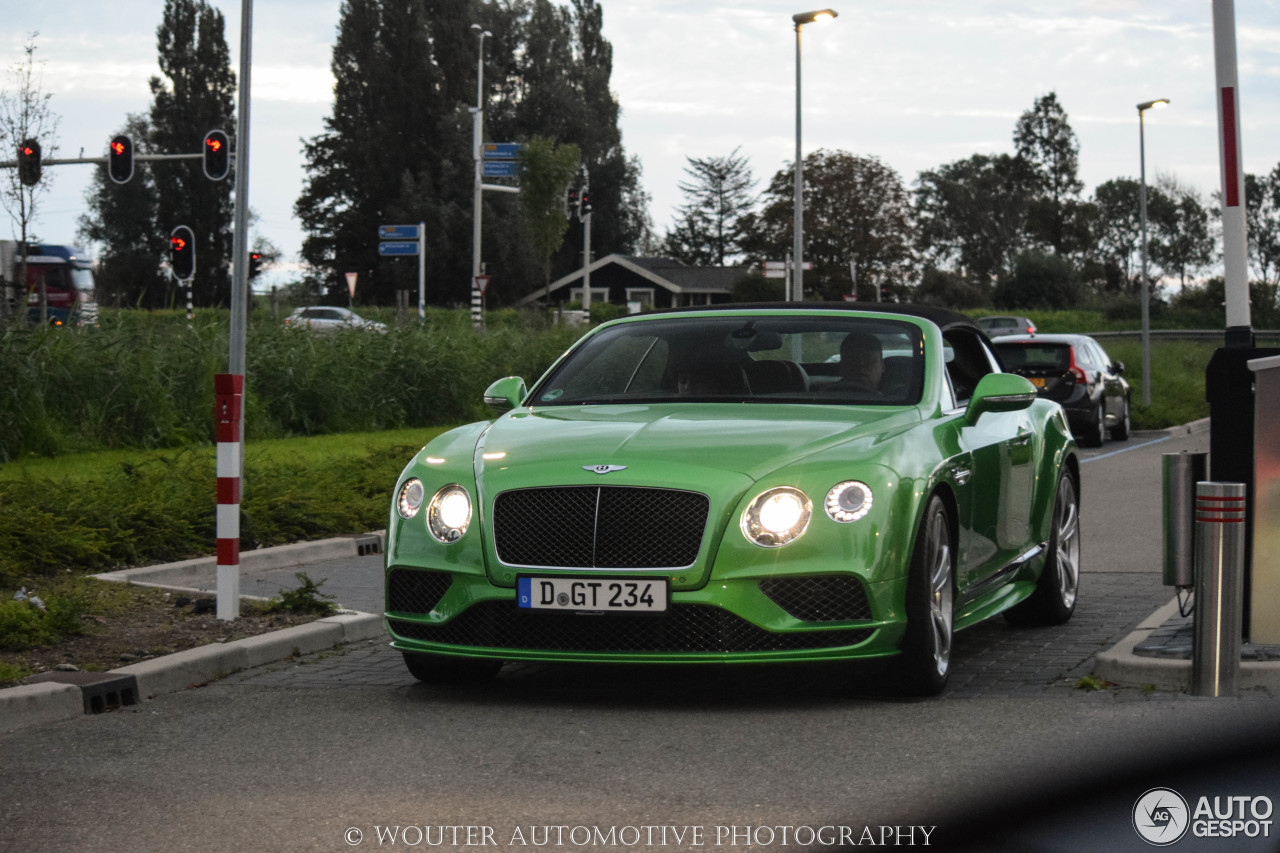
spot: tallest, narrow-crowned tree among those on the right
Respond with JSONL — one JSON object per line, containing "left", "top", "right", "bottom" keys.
{"left": 1014, "top": 92, "right": 1088, "bottom": 255}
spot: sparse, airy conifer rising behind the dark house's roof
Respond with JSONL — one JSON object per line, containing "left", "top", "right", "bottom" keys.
{"left": 664, "top": 147, "right": 755, "bottom": 266}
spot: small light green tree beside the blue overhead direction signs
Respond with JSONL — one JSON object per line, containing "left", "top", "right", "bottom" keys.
{"left": 520, "top": 136, "right": 581, "bottom": 286}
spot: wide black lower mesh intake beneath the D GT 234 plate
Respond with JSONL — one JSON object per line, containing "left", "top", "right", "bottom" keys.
{"left": 389, "top": 601, "right": 873, "bottom": 652}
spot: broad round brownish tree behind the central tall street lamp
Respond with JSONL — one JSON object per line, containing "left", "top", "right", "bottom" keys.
{"left": 749, "top": 150, "right": 915, "bottom": 300}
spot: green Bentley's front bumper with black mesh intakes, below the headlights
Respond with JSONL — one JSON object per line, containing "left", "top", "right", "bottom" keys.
{"left": 385, "top": 567, "right": 905, "bottom": 663}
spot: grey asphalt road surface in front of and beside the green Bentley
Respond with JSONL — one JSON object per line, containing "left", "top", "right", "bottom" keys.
{"left": 0, "top": 422, "right": 1280, "bottom": 850}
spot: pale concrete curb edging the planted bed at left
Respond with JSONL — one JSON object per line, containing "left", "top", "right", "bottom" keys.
{"left": 0, "top": 534, "right": 385, "bottom": 731}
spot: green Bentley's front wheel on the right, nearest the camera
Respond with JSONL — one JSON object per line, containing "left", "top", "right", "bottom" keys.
{"left": 899, "top": 494, "right": 955, "bottom": 695}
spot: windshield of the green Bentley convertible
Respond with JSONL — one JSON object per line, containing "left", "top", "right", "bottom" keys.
{"left": 531, "top": 315, "right": 924, "bottom": 406}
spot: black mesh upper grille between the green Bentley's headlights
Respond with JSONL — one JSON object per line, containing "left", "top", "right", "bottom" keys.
{"left": 493, "top": 485, "right": 710, "bottom": 569}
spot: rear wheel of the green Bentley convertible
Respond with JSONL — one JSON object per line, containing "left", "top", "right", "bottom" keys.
{"left": 1005, "top": 470, "right": 1080, "bottom": 625}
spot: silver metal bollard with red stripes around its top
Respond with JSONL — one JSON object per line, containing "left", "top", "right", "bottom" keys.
{"left": 1192, "top": 482, "right": 1245, "bottom": 697}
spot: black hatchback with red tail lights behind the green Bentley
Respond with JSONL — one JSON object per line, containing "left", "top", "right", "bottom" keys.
{"left": 992, "top": 334, "right": 1129, "bottom": 447}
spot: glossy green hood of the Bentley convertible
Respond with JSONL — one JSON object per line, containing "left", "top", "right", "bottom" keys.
{"left": 476, "top": 403, "right": 919, "bottom": 488}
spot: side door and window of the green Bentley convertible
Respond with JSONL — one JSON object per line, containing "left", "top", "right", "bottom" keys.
{"left": 943, "top": 327, "right": 1037, "bottom": 602}
